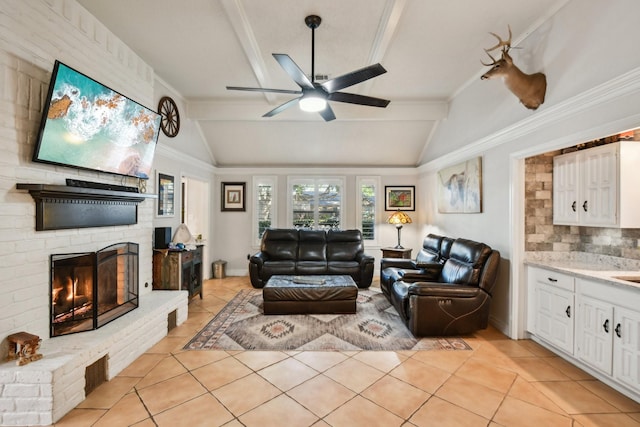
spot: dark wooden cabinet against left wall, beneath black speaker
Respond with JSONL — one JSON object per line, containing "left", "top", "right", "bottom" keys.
{"left": 153, "top": 245, "right": 203, "bottom": 299}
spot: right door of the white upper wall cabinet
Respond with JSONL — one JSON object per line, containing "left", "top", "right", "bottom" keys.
{"left": 578, "top": 145, "right": 618, "bottom": 226}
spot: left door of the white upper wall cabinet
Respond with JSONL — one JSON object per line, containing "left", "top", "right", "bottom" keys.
{"left": 553, "top": 153, "right": 578, "bottom": 224}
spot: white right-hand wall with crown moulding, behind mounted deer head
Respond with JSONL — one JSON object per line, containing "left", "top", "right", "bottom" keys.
{"left": 419, "top": 0, "right": 640, "bottom": 336}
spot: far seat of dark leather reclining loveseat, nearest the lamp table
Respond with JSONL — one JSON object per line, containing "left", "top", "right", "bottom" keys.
{"left": 380, "top": 234, "right": 454, "bottom": 298}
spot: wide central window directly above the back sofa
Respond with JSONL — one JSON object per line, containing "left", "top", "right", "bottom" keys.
{"left": 288, "top": 178, "right": 344, "bottom": 229}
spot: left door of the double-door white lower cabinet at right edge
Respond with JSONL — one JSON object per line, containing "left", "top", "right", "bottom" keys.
{"left": 576, "top": 295, "right": 615, "bottom": 375}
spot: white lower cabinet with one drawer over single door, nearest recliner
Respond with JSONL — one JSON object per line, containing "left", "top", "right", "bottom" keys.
{"left": 528, "top": 267, "right": 575, "bottom": 354}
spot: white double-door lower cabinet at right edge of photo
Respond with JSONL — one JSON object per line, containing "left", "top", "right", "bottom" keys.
{"left": 575, "top": 279, "right": 640, "bottom": 390}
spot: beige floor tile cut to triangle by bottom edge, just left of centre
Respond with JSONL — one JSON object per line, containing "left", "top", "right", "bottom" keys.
{"left": 239, "top": 394, "right": 318, "bottom": 427}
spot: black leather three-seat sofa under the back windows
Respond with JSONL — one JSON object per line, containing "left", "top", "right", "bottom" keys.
{"left": 249, "top": 229, "right": 374, "bottom": 288}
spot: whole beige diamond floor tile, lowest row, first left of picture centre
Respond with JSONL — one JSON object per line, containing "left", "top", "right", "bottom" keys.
{"left": 211, "top": 373, "right": 282, "bottom": 416}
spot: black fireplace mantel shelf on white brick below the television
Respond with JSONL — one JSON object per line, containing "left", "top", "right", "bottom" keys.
{"left": 16, "top": 184, "right": 157, "bottom": 231}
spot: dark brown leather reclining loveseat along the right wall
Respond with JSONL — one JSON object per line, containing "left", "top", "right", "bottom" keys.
{"left": 381, "top": 235, "right": 500, "bottom": 336}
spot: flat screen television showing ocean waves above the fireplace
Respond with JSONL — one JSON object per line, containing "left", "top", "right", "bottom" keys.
{"left": 33, "top": 61, "right": 161, "bottom": 179}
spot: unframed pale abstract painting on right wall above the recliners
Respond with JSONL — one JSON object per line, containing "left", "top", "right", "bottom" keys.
{"left": 438, "top": 157, "right": 482, "bottom": 213}
